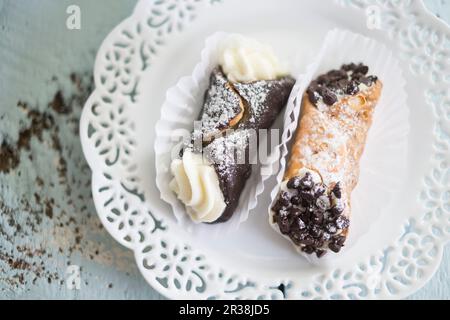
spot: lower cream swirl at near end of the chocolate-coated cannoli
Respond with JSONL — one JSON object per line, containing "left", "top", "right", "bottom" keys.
{"left": 170, "top": 150, "right": 226, "bottom": 223}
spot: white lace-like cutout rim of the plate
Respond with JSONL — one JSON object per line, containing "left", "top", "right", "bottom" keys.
{"left": 80, "top": 0, "right": 450, "bottom": 299}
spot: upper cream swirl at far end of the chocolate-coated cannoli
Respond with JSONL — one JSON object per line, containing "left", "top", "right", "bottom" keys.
{"left": 219, "top": 35, "right": 287, "bottom": 82}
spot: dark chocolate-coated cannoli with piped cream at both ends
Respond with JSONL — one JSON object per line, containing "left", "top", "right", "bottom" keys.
{"left": 170, "top": 37, "right": 294, "bottom": 223}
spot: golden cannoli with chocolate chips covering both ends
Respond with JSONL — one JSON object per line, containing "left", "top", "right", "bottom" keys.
{"left": 269, "top": 63, "right": 382, "bottom": 258}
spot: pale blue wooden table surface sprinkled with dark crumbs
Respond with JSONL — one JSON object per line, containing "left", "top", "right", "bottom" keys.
{"left": 0, "top": 0, "right": 450, "bottom": 299}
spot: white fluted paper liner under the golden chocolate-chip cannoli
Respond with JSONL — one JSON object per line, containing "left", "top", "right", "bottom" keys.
{"left": 269, "top": 29, "right": 409, "bottom": 263}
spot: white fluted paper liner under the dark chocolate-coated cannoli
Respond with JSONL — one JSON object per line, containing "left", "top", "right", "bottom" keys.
{"left": 155, "top": 32, "right": 309, "bottom": 236}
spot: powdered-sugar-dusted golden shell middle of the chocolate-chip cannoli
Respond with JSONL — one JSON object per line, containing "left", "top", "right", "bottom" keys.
{"left": 291, "top": 85, "right": 378, "bottom": 195}
